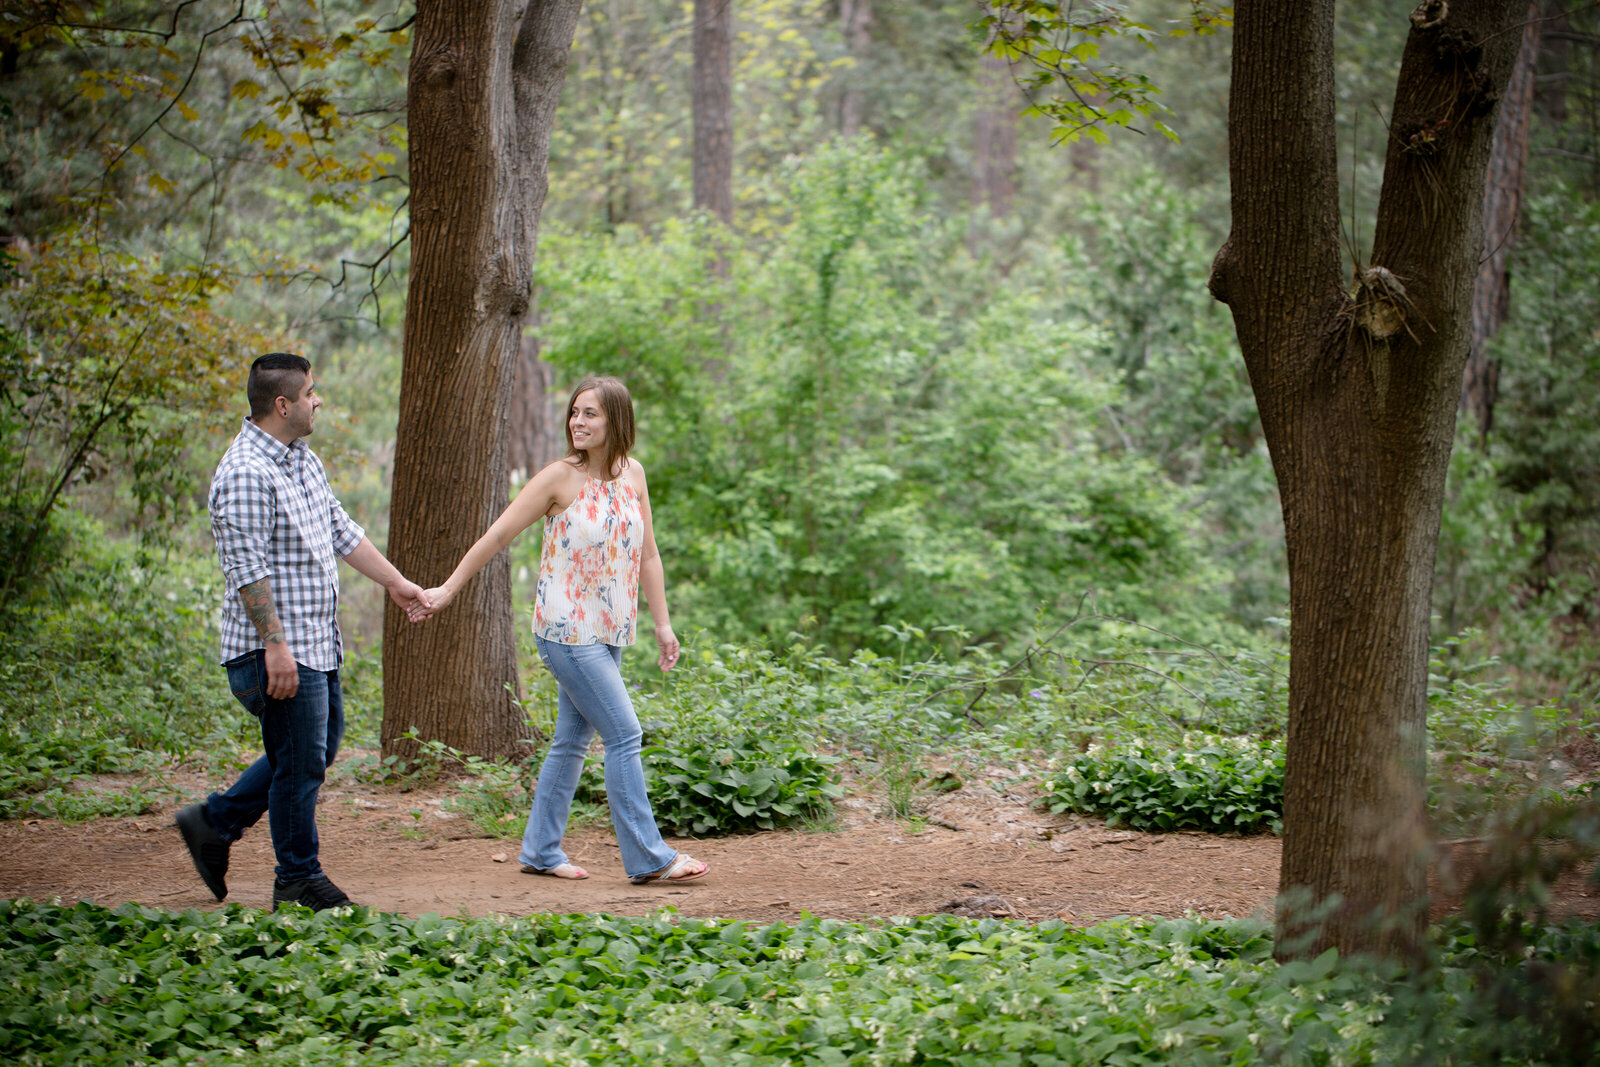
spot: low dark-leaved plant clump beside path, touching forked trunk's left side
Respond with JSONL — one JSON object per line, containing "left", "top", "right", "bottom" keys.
{"left": 1040, "top": 736, "right": 1285, "bottom": 833}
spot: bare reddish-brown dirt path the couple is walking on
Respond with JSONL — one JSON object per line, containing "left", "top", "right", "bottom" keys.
{"left": 0, "top": 755, "right": 1600, "bottom": 923}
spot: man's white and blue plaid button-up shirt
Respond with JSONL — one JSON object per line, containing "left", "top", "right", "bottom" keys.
{"left": 210, "top": 419, "right": 365, "bottom": 670}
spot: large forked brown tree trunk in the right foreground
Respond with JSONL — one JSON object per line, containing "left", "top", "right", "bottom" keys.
{"left": 1211, "top": 0, "right": 1526, "bottom": 957}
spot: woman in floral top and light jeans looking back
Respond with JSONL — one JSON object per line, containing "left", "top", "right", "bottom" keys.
{"left": 411, "top": 376, "right": 707, "bottom": 885}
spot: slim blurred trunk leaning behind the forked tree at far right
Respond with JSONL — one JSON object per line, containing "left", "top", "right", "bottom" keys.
{"left": 1461, "top": 0, "right": 1542, "bottom": 446}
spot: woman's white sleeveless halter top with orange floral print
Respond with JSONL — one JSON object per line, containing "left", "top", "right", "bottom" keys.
{"left": 533, "top": 477, "right": 645, "bottom": 645}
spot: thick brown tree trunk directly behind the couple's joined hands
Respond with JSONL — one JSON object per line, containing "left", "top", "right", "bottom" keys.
{"left": 382, "top": 0, "right": 579, "bottom": 767}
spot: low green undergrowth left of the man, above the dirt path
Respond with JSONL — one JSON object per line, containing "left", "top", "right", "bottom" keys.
{"left": 0, "top": 510, "right": 246, "bottom": 819}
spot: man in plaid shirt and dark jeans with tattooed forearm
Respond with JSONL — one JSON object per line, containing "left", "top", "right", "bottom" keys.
{"left": 176, "top": 352, "right": 422, "bottom": 912}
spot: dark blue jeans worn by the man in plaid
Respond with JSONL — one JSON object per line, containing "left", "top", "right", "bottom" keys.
{"left": 206, "top": 648, "right": 344, "bottom": 881}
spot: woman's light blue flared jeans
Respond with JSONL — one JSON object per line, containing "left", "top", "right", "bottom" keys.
{"left": 518, "top": 637, "right": 678, "bottom": 878}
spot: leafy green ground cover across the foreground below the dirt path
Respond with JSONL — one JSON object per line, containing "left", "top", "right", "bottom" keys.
{"left": 0, "top": 901, "right": 1597, "bottom": 1065}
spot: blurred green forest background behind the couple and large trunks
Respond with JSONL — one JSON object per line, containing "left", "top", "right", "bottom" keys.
{"left": 0, "top": 0, "right": 1600, "bottom": 729}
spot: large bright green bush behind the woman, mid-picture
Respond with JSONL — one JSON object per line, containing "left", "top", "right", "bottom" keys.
{"left": 530, "top": 142, "right": 1222, "bottom": 654}
